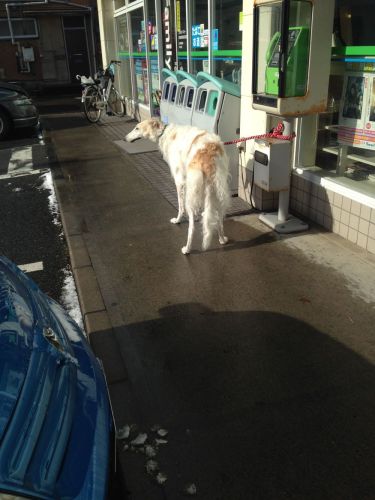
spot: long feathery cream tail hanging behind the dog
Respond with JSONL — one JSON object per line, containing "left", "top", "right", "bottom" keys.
{"left": 202, "top": 153, "right": 230, "bottom": 250}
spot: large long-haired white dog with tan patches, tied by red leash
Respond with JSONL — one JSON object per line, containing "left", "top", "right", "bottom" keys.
{"left": 125, "top": 118, "right": 230, "bottom": 254}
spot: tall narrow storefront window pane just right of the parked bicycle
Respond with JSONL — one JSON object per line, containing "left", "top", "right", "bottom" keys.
{"left": 130, "top": 8, "right": 149, "bottom": 104}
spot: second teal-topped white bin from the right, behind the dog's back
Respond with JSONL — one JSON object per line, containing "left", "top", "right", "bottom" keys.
{"left": 173, "top": 70, "right": 198, "bottom": 125}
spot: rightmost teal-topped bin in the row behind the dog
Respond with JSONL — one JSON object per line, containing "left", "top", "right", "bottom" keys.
{"left": 191, "top": 71, "right": 241, "bottom": 194}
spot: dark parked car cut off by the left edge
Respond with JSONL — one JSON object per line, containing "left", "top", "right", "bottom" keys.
{"left": 0, "top": 82, "right": 39, "bottom": 140}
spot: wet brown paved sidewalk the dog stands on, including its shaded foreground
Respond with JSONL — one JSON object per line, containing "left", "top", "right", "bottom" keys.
{"left": 41, "top": 97, "right": 375, "bottom": 500}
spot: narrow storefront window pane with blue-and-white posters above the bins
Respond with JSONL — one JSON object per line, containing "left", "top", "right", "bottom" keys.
{"left": 191, "top": 0, "right": 209, "bottom": 74}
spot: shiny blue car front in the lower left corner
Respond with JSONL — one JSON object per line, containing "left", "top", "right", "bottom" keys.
{"left": 0, "top": 257, "right": 115, "bottom": 500}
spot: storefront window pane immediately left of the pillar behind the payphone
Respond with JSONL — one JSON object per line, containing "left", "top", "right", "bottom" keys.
{"left": 212, "top": 0, "right": 242, "bottom": 84}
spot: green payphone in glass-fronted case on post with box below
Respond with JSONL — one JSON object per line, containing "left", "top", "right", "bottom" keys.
{"left": 252, "top": 0, "right": 335, "bottom": 233}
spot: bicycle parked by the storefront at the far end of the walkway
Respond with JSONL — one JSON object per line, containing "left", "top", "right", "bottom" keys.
{"left": 76, "top": 60, "right": 126, "bottom": 123}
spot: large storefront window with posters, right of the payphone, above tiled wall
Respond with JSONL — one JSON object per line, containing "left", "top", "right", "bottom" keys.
{"left": 316, "top": 0, "right": 375, "bottom": 197}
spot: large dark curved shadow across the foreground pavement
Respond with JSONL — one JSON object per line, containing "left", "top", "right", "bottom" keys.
{"left": 91, "top": 304, "right": 375, "bottom": 500}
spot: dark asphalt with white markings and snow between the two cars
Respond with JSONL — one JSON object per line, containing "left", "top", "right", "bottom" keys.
{"left": 0, "top": 124, "right": 82, "bottom": 326}
